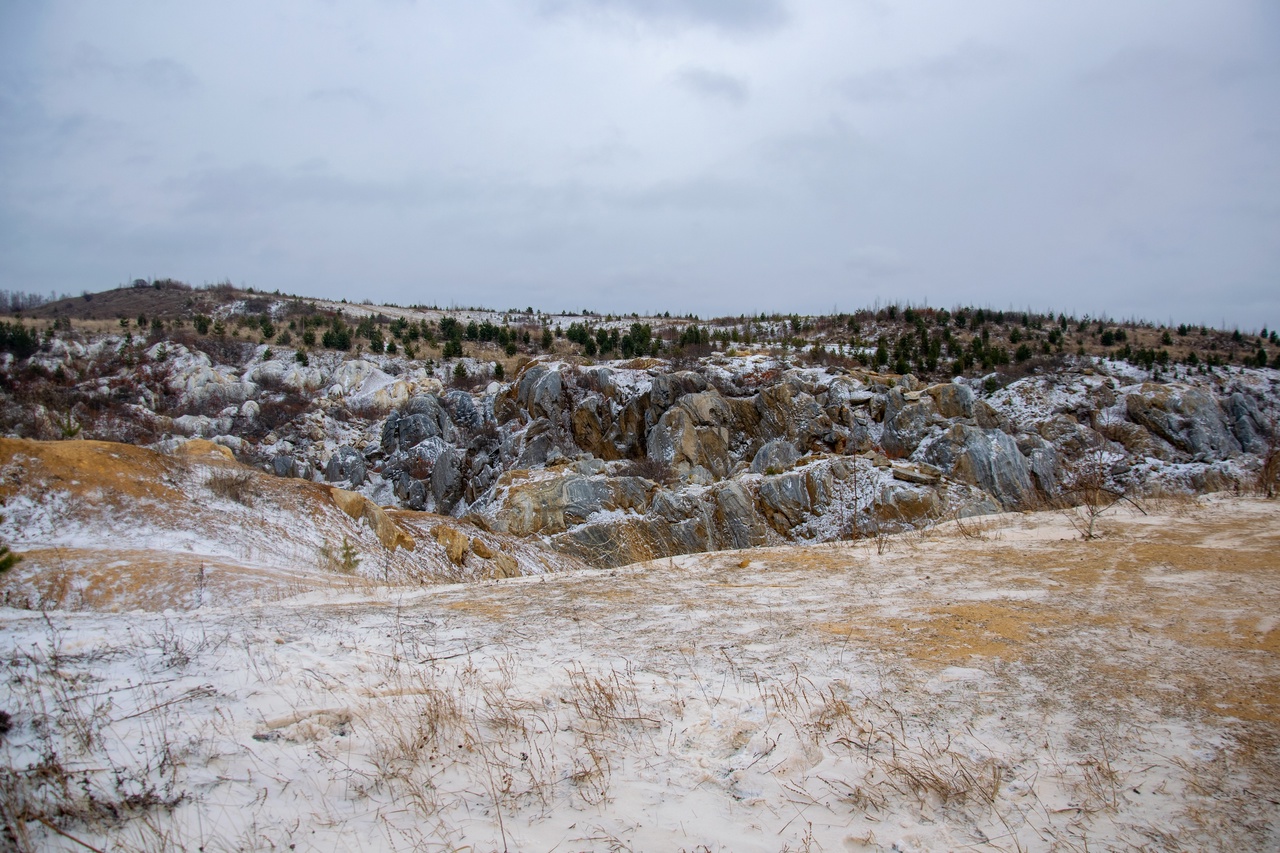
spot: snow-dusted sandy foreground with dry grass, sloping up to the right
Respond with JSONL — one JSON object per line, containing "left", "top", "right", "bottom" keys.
{"left": 0, "top": 498, "right": 1280, "bottom": 852}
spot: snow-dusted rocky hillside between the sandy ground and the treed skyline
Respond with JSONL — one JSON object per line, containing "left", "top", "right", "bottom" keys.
{"left": 0, "top": 284, "right": 1280, "bottom": 579}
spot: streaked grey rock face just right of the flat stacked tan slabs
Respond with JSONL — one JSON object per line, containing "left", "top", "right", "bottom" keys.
{"left": 924, "top": 424, "right": 1036, "bottom": 508}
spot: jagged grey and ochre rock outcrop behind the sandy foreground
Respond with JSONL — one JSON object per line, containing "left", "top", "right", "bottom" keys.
{"left": 232, "top": 350, "right": 1270, "bottom": 576}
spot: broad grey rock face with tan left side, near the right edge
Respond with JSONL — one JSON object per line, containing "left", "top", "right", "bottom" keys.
{"left": 1125, "top": 383, "right": 1240, "bottom": 461}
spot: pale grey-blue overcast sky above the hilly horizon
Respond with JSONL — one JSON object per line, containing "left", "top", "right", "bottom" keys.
{"left": 0, "top": 0, "right": 1280, "bottom": 329}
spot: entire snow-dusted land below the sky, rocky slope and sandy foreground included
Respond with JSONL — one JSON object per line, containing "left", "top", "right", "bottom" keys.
{"left": 0, "top": 284, "right": 1280, "bottom": 852}
